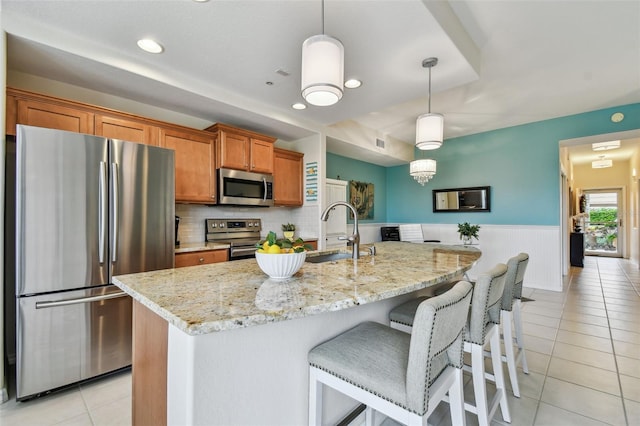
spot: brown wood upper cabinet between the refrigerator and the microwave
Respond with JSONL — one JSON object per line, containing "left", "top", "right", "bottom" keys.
{"left": 160, "top": 128, "right": 216, "bottom": 204}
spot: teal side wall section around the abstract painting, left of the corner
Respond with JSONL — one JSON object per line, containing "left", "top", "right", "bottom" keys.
{"left": 327, "top": 152, "right": 387, "bottom": 223}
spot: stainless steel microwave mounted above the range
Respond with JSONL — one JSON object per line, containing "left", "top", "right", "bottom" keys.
{"left": 218, "top": 169, "right": 273, "bottom": 207}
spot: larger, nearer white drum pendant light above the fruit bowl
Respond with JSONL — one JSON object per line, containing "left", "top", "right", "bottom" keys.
{"left": 302, "top": 0, "right": 344, "bottom": 106}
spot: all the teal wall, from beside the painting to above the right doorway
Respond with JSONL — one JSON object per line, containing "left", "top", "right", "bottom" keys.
{"left": 327, "top": 104, "right": 640, "bottom": 226}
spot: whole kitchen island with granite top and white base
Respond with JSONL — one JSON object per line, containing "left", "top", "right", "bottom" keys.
{"left": 114, "top": 242, "right": 480, "bottom": 425}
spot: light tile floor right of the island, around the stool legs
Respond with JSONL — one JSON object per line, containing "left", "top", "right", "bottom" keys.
{"left": 429, "top": 257, "right": 640, "bottom": 426}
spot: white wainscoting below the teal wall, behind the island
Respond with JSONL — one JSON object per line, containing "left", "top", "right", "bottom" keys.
{"left": 360, "top": 223, "right": 562, "bottom": 291}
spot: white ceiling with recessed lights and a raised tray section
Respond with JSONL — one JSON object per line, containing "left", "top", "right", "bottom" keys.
{"left": 0, "top": 0, "right": 640, "bottom": 165}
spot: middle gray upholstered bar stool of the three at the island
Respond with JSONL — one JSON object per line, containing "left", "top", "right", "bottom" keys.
{"left": 389, "top": 263, "right": 511, "bottom": 426}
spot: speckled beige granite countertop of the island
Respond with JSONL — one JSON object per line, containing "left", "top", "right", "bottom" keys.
{"left": 113, "top": 242, "right": 481, "bottom": 335}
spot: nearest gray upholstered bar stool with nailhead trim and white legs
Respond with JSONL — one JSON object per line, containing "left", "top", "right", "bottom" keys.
{"left": 309, "top": 281, "right": 472, "bottom": 425}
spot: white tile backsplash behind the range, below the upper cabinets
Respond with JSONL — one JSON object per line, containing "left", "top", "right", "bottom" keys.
{"left": 176, "top": 204, "right": 320, "bottom": 244}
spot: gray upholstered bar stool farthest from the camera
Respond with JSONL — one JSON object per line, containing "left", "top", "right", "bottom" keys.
{"left": 500, "top": 253, "right": 529, "bottom": 398}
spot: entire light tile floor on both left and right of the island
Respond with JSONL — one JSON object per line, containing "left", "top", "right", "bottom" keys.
{"left": 0, "top": 257, "right": 640, "bottom": 426}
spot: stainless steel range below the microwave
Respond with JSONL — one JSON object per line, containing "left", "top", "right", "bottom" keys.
{"left": 205, "top": 219, "right": 262, "bottom": 260}
